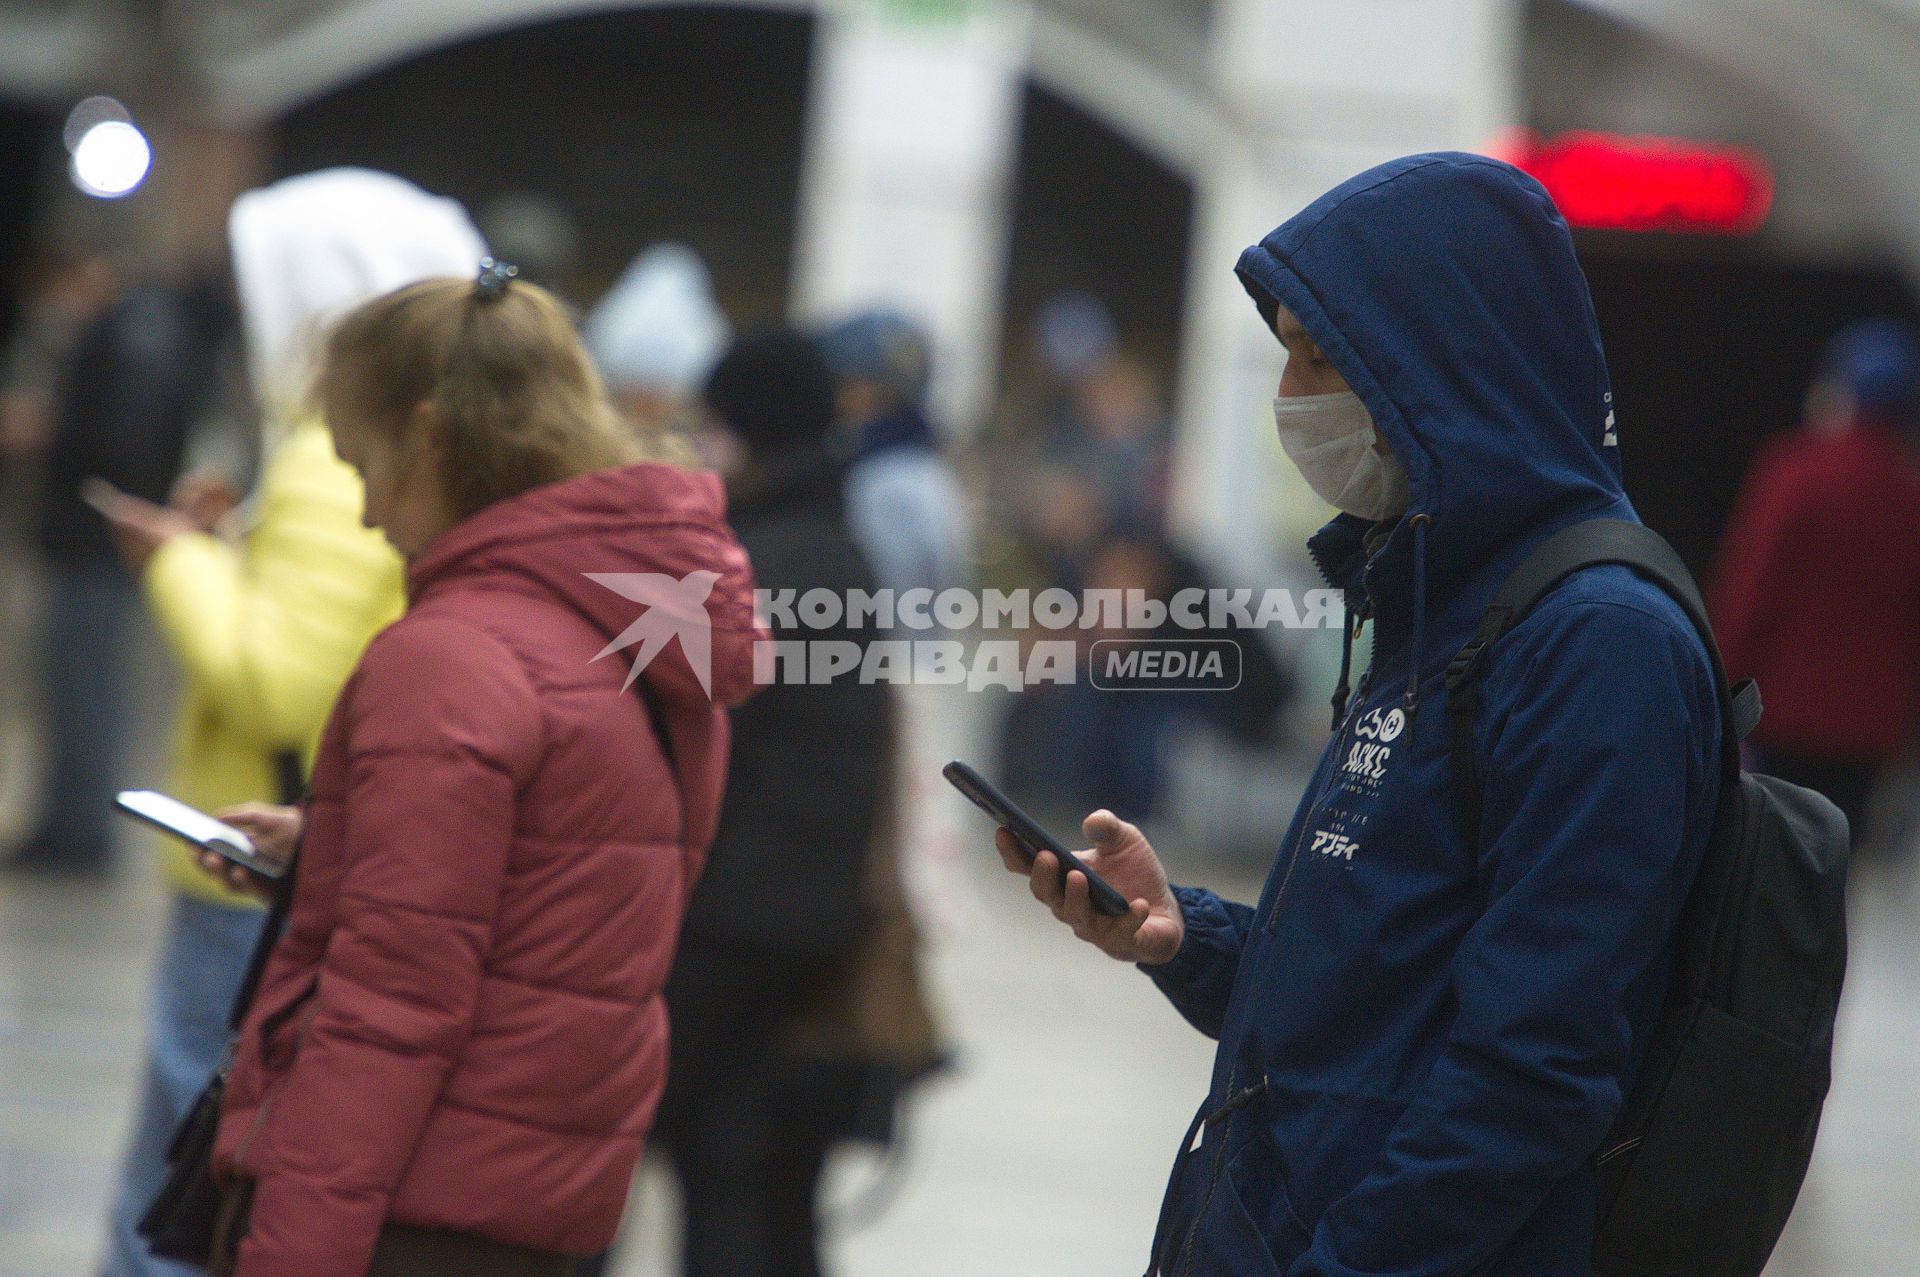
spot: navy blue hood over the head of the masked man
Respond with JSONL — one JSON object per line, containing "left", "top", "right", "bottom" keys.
{"left": 1236, "top": 152, "right": 1624, "bottom": 591}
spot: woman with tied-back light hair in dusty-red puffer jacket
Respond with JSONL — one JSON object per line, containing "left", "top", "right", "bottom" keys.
{"left": 202, "top": 268, "right": 758, "bottom": 1277}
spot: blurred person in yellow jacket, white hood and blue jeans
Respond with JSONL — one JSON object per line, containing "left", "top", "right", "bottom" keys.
{"left": 94, "top": 169, "right": 486, "bottom": 1277}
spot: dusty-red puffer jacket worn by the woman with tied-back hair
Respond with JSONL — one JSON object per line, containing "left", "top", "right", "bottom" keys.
{"left": 215, "top": 465, "right": 756, "bottom": 1277}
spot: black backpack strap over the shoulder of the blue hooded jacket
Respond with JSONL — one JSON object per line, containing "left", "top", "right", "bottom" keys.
{"left": 1446, "top": 518, "right": 1761, "bottom": 833}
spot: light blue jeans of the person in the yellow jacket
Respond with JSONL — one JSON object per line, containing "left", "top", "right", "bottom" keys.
{"left": 100, "top": 895, "right": 267, "bottom": 1277}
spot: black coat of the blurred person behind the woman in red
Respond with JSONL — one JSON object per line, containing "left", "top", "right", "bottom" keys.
{"left": 660, "top": 449, "right": 937, "bottom": 1139}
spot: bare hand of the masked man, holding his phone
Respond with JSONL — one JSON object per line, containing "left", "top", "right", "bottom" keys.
{"left": 993, "top": 808, "right": 1187, "bottom": 966}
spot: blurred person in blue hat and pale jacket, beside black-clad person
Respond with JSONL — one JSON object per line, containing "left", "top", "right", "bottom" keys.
{"left": 822, "top": 309, "right": 970, "bottom": 614}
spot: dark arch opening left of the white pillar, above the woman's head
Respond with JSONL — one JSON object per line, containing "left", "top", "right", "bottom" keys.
{"left": 276, "top": 6, "right": 812, "bottom": 323}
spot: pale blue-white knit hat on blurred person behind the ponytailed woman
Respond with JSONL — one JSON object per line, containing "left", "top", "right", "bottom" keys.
{"left": 584, "top": 244, "right": 733, "bottom": 396}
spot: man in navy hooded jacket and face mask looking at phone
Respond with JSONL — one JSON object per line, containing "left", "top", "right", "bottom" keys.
{"left": 1000, "top": 154, "right": 1720, "bottom": 1277}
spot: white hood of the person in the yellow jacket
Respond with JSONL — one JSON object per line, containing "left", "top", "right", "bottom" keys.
{"left": 227, "top": 169, "right": 486, "bottom": 417}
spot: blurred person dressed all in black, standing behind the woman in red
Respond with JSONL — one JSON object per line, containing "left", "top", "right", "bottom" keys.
{"left": 584, "top": 330, "right": 931, "bottom": 1277}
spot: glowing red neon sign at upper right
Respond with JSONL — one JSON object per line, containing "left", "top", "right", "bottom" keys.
{"left": 1496, "top": 133, "right": 1774, "bottom": 234}
